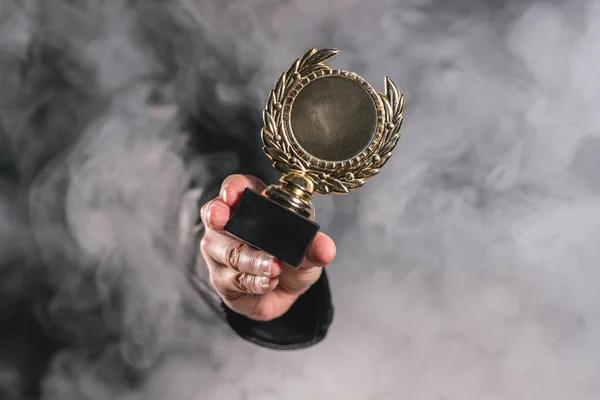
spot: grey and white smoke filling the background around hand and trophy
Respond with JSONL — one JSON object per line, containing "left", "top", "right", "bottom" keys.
{"left": 0, "top": 0, "right": 600, "bottom": 400}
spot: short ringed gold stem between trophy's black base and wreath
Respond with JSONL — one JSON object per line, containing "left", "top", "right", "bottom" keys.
{"left": 263, "top": 172, "right": 315, "bottom": 221}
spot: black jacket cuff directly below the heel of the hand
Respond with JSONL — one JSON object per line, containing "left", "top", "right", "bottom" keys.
{"left": 222, "top": 271, "right": 333, "bottom": 350}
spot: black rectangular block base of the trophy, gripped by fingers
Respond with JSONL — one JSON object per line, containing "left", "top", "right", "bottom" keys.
{"left": 225, "top": 189, "right": 319, "bottom": 267}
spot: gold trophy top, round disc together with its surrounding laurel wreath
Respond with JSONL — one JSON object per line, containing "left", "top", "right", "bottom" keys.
{"left": 261, "top": 49, "right": 404, "bottom": 194}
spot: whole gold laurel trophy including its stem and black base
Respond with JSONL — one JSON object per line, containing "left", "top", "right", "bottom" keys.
{"left": 225, "top": 49, "right": 404, "bottom": 267}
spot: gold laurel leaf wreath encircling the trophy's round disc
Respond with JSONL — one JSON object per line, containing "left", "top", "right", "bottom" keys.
{"left": 261, "top": 49, "right": 404, "bottom": 194}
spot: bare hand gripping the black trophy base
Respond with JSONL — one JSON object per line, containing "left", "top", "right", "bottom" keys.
{"left": 200, "top": 175, "right": 335, "bottom": 321}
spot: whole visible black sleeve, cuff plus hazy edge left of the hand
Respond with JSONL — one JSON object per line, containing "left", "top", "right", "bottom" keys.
{"left": 180, "top": 191, "right": 333, "bottom": 350}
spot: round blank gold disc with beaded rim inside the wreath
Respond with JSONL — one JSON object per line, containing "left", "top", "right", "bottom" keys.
{"left": 283, "top": 70, "right": 384, "bottom": 171}
